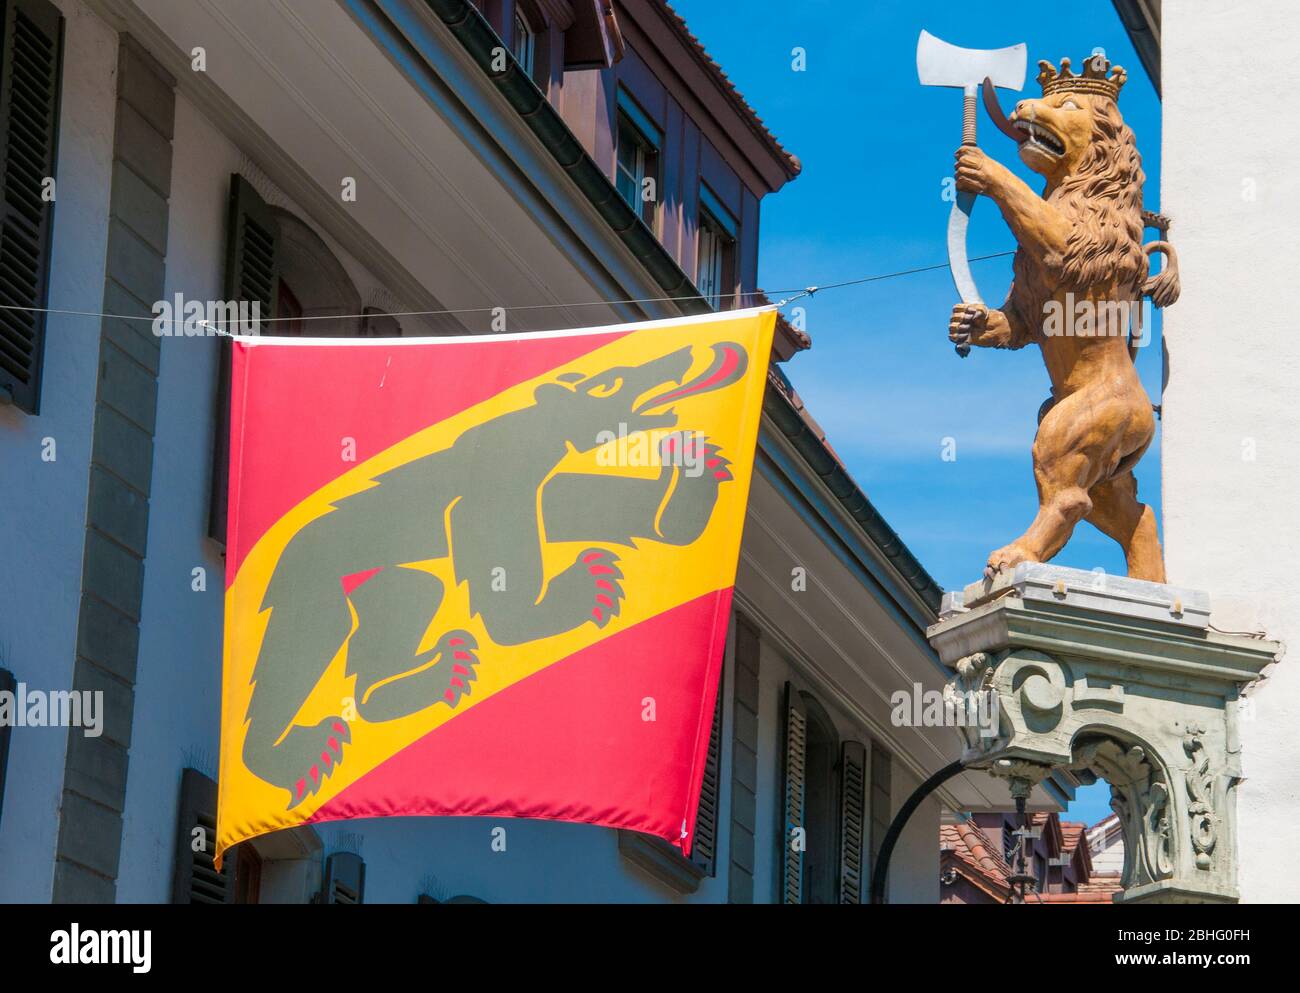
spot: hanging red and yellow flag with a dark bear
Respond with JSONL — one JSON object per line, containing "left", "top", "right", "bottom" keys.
{"left": 217, "top": 308, "right": 776, "bottom": 860}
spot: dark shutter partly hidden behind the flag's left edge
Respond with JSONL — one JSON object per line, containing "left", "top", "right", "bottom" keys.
{"left": 208, "top": 173, "right": 280, "bottom": 545}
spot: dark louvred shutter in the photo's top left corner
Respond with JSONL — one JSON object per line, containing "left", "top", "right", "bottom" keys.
{"left": 0, "top": 0, "right": 64, "bottom": 413}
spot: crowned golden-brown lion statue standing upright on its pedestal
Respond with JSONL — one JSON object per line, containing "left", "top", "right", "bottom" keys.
{"left": 949, "top": 55, "right": 1178, "bottom": 582}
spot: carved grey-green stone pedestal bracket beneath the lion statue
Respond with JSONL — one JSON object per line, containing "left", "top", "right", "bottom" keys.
{"left": 927, "top": 563, "right": 1279, "bottom": 902}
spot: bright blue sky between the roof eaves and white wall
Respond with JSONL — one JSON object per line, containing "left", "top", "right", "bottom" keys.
{"left": 673, "top": 0, "right": 1161, "bottom": 823}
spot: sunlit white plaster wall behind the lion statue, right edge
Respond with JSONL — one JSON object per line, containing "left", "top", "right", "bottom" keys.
{"left": 1161, "top": 0, "right": 1300, "bottom": 902}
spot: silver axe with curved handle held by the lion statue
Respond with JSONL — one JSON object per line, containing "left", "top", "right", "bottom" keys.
{"left": 917, "top": 31, "right": 1028, "bottom": 359}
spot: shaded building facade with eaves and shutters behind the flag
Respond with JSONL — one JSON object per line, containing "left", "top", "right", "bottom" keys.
{"left": 0, "top": 0, "right": 1045, "bottom": 902}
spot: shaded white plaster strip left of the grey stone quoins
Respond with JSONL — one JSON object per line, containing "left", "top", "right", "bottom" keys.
{"left": 0, "top": 0, "right": 117, "bottom": 902}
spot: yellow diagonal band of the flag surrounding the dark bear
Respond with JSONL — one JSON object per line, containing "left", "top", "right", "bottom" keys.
{"left": 218, "top": 312, "right": 776, "bottom": 850}
